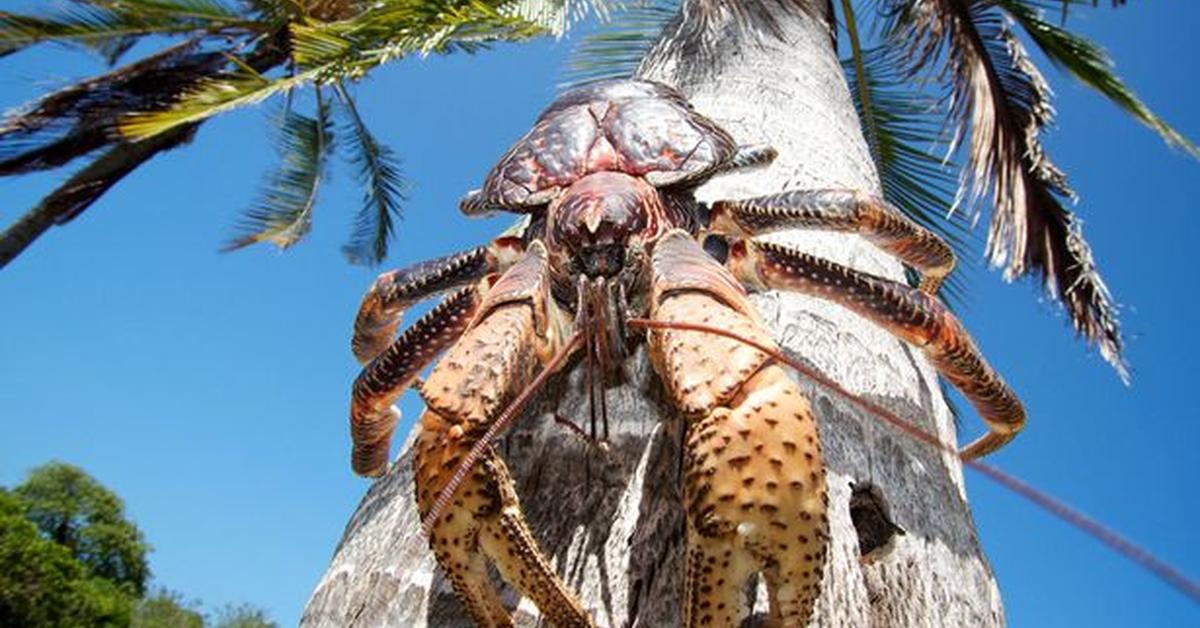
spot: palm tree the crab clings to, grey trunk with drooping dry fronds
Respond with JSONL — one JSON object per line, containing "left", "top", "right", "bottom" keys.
{"left": 302, "top": 0, "right": 1196, "bottom": 626}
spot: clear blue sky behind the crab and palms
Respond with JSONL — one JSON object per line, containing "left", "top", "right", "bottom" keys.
{"left": 0, "top": 0, "right": 1200, "bottom": 626}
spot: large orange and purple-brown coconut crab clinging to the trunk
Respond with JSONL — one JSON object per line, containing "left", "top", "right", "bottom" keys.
{"left": 350, "top": 80, "right": 1025, "bottom": 627}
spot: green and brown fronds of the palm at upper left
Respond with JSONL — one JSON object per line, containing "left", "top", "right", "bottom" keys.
{"left": 0, "top": 0, "right": 590, "bottom": 268}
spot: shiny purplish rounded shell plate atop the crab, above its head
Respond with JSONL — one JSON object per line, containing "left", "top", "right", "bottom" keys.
{"left": 478, "top": 79, "right": 737, "bottom": 211}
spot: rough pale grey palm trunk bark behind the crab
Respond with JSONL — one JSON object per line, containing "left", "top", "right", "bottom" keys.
{"left": 301, "top": 2, "right": 1003, "bottom": 627}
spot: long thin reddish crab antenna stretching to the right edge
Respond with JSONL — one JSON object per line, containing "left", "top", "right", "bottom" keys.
{"left": 625, "top": 318, "right": 1200, "bottom": 602}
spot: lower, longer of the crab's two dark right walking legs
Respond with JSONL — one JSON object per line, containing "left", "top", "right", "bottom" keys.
{"left": 726, "top": 240, "right": 1025, "bottom": 460}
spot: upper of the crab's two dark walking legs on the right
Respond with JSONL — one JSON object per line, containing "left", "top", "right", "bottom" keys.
{"left": 708, "top": 190, "right": 954, "bottom": 294}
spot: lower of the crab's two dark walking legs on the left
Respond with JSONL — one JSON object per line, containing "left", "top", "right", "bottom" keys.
{"left": 350, "top": 286, "right": 482, "bottom": 477}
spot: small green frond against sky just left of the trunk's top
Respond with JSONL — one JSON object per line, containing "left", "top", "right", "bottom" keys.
{"left": 560, "top": 0, "right": 680, "bottom": 89}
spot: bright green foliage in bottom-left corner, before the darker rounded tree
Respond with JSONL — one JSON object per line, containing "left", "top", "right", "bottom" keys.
{"left": 0, "top": 489, "right": 133, "bottom": 628}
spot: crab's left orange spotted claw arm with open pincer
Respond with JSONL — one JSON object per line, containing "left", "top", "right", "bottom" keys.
{"left": 413, "top": 241, "right": 592, "bottom": 627}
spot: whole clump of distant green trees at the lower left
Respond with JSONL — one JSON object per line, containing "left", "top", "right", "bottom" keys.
{"left": 0, "top": 462, "right": 277, "bottom": 628}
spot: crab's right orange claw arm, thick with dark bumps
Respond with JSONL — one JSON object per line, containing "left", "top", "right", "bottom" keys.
{"left": 648, "top": 231, "right": 829, "bottom": 627}
